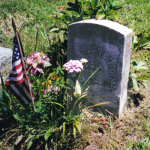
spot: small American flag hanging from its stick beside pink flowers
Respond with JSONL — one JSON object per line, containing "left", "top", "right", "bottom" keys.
{"left": 5, "top": 34, "right": 34, "bottom": 106}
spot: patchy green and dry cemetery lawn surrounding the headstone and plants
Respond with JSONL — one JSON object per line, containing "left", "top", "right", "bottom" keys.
{"left": 0, "top": 0, "right": 150, "bottom": 150}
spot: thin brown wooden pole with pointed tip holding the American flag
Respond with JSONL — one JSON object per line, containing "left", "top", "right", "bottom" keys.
{"left": 12, "top": 18, "right": 36, "bottom": 114}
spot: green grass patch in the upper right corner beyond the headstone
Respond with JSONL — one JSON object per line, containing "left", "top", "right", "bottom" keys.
{"left": 119, "top": 0, "right": 150, "bottom": 36}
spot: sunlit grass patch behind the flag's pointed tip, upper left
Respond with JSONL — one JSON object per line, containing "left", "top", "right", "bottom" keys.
{"left": 0, "top": 0, "right": 67, "bottom": 54}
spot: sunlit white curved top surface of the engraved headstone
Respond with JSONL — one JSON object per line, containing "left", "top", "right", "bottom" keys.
{"left": 69, "top": 19, "right": 132, "bottom": 35}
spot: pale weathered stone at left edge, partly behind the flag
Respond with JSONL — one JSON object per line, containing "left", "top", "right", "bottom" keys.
{"left": 0, "top": 47, "right": 13, "bottom": 84}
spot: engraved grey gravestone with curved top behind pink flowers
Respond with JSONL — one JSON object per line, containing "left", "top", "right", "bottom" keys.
{"left": 67, "top": 19, "right": 132, "bottom": 117}
